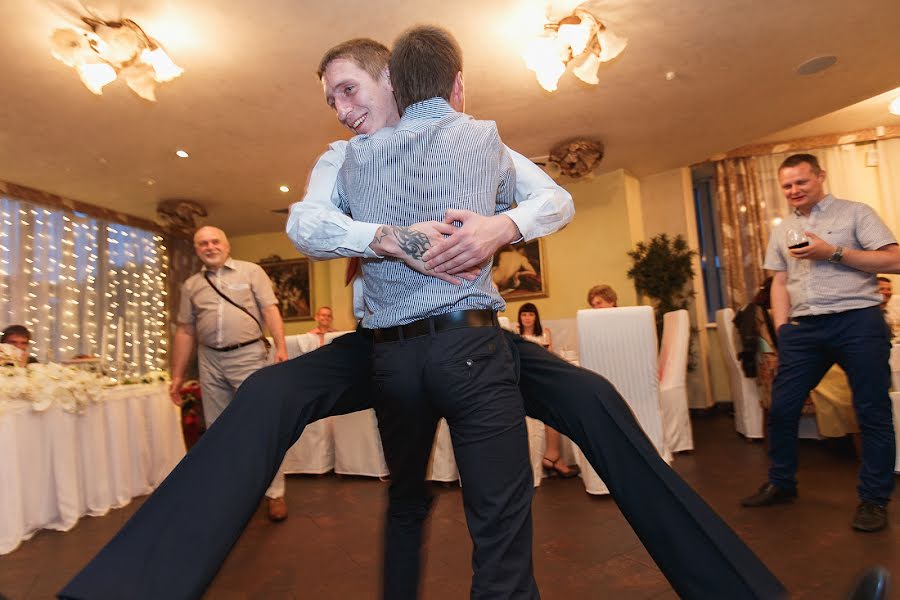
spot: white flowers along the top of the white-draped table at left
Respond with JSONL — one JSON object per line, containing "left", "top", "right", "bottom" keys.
{"left": 0, "top": 360, "right": 163, "bottom": 413}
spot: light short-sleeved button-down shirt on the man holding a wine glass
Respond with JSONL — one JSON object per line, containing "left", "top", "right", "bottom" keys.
{"left": 763, "top": 194, "right": 897, "bottom": 317}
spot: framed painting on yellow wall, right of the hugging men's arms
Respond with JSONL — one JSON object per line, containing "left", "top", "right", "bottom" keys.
{"left": 491, "top": 239, "right": 548, "bottom": 301}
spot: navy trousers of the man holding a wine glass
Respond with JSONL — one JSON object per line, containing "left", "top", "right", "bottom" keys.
{"left": 769, "top": 306, "right": 896, "bottom": 506}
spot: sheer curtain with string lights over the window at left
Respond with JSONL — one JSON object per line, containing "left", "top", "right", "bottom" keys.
{"left": 0, "top": 197, "right": 167, "bottom": 373}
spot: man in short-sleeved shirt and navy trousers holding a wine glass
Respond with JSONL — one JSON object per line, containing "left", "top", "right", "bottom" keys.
{"left": 741, "top": 154, "right": 900, "bottom": 531}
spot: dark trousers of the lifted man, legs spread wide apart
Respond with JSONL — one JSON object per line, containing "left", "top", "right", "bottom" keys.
{"left": 60, "top": 333, "right": 784, "bottom": 600}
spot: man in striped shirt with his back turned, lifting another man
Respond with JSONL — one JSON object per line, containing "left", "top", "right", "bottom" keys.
{"left": 337, "top": 27, "right": 539, "bottom": 598}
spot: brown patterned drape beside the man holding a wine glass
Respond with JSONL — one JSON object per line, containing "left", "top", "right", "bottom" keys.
{"left": 715, "top": 158, "right": 769, "bottom": 308}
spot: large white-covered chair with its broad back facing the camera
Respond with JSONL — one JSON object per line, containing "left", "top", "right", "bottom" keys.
{"left": 576, "top": 306, "right": 672, "bottom": 494}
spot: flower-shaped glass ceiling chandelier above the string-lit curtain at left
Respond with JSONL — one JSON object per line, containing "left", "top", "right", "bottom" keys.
{"left": 50, "top": 17, "right": 184, "bottom": 102}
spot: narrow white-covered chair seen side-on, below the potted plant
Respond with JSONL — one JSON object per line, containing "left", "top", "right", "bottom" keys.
{"left": 659, "top": 309, "right": 694, "bottom": 452}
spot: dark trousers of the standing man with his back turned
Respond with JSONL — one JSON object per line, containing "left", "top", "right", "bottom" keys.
{"left": 373, "top": 327, "right": 540, "bottom": 600}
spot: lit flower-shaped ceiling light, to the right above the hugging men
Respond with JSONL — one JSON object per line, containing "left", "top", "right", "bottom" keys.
{"left": 522, "top": 8, "right": 628, "bottom": 92}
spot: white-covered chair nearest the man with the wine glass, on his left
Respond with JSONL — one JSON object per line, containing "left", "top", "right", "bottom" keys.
{"left": 716, "top": 308, "right": 765, "bottom": 439}
